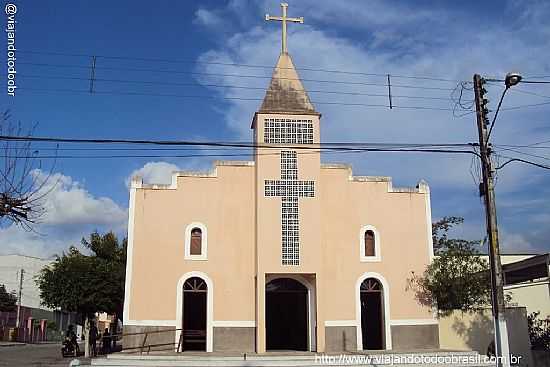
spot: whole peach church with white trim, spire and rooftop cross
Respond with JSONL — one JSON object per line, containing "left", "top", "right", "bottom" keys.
{"left": 124, "top": 4, "right": 439, "bottom": 353}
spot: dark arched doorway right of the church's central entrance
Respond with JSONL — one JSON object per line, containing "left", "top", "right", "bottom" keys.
{"left": 360, "top": 278, "right": 384, "bottom": 349}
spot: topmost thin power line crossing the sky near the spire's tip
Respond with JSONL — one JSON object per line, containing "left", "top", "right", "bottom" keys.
{"left": 17, "top": 50, "right": 457, "bottom": 83}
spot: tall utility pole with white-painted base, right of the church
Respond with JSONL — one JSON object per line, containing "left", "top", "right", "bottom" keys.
{"left": 474, "top": 74, "right": 510, "bottom": 366}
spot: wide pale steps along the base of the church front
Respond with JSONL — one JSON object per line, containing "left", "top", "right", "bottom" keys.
{"left": 92, "top": 351, "right": 494, "bottom": 367}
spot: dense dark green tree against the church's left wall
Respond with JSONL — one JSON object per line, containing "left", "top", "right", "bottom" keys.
{"left": 37, "top": 232, "right": 126, "bottom": 317}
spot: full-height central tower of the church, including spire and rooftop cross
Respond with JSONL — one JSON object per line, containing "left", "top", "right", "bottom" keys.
{"left": 252, "top": 3, "right": 324, "bottom": 352}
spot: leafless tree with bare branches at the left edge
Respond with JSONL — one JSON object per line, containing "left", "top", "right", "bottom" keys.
{"left": 0, "top": 111, "right": 55, "bottom": 230}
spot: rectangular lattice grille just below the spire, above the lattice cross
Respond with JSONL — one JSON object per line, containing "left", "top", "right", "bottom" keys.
{"left": 264, "top": 118, "right": 313, "bottom": 144}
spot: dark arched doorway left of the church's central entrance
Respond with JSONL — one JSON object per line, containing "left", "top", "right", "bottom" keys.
{"left": 181, "top": 277, "right": 208, "bottom": 351}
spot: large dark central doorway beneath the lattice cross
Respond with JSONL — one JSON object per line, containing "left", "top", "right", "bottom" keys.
{"left": 265, "top": 278, "right": 308, "bottom": 351}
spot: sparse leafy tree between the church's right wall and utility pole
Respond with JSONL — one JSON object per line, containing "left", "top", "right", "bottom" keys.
{"left": 408, "top": 217, "right": 491, "bottom": 315}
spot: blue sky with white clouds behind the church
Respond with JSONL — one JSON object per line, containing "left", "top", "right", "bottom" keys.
{"left": 0, "top": 0, "right": 550, "bottom": 256}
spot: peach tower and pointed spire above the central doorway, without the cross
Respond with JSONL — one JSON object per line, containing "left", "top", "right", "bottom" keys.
{"left": 252, "top": 53, "right": 321, "bottom": 267}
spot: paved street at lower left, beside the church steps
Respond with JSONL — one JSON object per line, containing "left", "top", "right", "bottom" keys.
{"left": 0, "top": 343, "right": 90, "bottom": 367}
